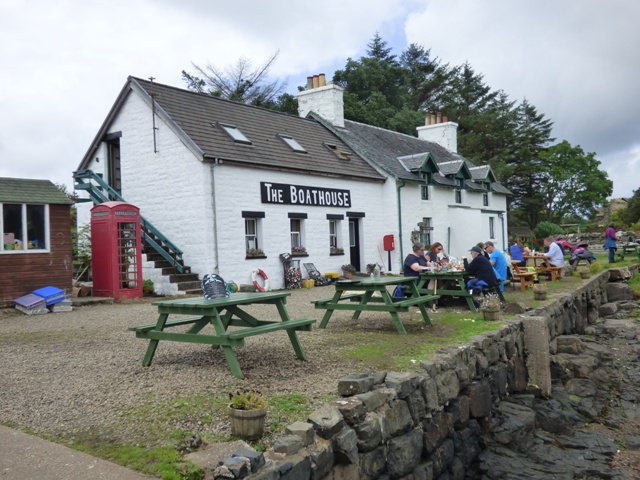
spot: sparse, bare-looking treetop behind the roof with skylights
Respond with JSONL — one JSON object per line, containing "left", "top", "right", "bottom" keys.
{"left": 182, "top": 52, "right": 288, "bottom": 106}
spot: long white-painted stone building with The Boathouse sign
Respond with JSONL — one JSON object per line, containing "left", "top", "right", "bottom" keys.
{"left": 75, "top": 77, "right": 508, "bottom": 294}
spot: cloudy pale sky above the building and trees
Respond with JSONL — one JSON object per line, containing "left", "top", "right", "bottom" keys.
{"left": 0, "top": 0, "right": 640, "bottom": 198}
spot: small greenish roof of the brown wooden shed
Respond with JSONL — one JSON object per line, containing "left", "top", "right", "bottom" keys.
{"left": 0, "top": 177, "right": 73, "bottom": 205}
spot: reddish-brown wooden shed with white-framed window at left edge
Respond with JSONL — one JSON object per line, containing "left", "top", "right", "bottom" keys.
{"left": 0, "top": 177, "right": 73, "bottom": 307}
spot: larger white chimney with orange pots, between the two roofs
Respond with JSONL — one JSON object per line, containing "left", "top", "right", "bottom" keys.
{"left": 296, "top": 73, "right": 344, "bottom": 128}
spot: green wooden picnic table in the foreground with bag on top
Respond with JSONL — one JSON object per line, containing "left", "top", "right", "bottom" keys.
{"left": 129, "top": 292, "right": 315, "bottom": 378}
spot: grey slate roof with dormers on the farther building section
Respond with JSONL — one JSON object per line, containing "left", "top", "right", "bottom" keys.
{"left": 318, "top": 117, "right": 511, "bottom": 195}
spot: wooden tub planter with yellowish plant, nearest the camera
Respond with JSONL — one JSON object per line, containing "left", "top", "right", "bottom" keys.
{"left": 229, "top": 388, "right": 267, "bottom": 440}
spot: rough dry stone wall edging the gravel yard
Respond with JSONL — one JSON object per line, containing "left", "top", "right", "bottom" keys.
{"left": 212, "top": 268, "right": 640, "bottom": 480}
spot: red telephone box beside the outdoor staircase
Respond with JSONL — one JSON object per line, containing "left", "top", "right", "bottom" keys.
{"left": 91, "top": 202, "right": 142, "bottom": 300}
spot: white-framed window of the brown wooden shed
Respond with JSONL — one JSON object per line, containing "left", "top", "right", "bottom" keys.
{"left": 0, "top": 203, "right": 49, "bottom": 253}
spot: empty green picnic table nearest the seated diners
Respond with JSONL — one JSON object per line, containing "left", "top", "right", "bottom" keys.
{"left": 311, "top": 277, "right": 438, "bottom": 334}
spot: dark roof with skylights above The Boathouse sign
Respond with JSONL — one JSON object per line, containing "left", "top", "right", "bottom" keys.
{"left": 80, "top": 77, "right": 385, "bottom": 182}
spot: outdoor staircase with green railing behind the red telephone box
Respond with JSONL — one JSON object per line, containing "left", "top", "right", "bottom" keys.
{"left": 73, "top": 169, "right": 202, "bottom": 295}
